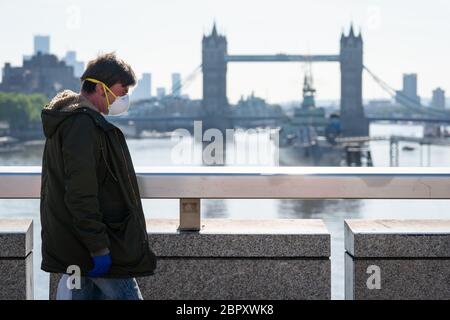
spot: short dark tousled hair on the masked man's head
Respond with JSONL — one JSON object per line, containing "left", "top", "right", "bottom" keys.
{"left": 80, "top": 52, "right": 136, "bottom": 93}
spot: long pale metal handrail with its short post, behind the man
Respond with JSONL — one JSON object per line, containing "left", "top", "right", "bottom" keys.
{"left": 0, "top": 166, "right": 450, "bottom": 230}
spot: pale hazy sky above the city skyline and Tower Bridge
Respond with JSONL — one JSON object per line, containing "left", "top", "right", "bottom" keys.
{"left": 0, "top": 0, "right": 450, "bottom": 102}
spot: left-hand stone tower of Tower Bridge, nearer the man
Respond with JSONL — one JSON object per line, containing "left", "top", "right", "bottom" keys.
{"left": 202, "top": 23, "right": 231, "bottom": 130}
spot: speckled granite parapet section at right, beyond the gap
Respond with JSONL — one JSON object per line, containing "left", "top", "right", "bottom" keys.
{"left": 345, "top": 220, "right": 450, "bottom": 300}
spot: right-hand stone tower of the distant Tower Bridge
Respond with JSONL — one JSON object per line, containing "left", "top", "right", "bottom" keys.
{"left": 340, "top": 25, "right": 369, "bottom": 136}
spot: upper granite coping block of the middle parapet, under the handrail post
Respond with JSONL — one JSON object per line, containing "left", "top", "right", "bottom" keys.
{"left": 147, "top": 219, "right": 330, "bottom": 258}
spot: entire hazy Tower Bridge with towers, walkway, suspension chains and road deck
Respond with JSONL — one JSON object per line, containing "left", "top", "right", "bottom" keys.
{"left": 111, "top": 24, "right": 450, "bottom": 137}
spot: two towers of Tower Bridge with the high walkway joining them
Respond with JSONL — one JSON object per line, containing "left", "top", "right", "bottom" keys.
{"left": 202, "top": 24, "right": 369, "bottom": 136}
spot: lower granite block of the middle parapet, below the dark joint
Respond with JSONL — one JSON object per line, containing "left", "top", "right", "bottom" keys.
{"left": 50, "top": 258, "right": 331, "bottom": 300}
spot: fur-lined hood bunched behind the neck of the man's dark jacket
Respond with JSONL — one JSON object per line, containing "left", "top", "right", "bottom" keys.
{"left": 41, "top": 90, "right": 112, "bottom": 138}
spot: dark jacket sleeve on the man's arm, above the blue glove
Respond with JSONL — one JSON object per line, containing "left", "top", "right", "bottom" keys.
{"left": 61, "top": 114, "right": 109, "bottom": 253}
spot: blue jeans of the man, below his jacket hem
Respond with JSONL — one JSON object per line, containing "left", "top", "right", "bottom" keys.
{"left": 56, "top": 274, "right": 142, "bottom": 300}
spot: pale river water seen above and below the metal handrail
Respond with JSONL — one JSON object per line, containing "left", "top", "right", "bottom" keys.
{"left": 0, "top": 124, "right": 450, "bottom": 299}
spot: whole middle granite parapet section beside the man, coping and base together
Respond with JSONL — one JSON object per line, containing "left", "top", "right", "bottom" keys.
{"left": 51, "top": 219, "right": 331, "bottom": 300}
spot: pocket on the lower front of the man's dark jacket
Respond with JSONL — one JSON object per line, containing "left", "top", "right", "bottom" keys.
{"left": 104, "top": 212, "right": 144, "bottom": 267}
